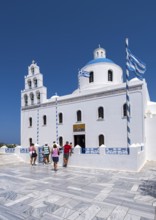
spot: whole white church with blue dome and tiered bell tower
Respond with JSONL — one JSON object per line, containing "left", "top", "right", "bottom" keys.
{"left": 21, "top": 47, "right": 156, "bottom": 170}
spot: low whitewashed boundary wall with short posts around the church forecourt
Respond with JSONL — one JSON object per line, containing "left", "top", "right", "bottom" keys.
{"left": 2, "top": 146, "right": 146, "bottom": 171}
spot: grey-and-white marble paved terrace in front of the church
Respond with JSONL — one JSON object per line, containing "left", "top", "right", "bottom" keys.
{"left": 0, "top": 154, "right": 156, "bottom": 220}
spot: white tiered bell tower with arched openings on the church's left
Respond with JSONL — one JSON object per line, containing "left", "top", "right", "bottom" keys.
{"left": 21, "top": 60, "right": 47, "bottom": 107}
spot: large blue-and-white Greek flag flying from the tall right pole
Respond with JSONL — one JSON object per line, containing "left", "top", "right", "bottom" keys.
{"left": 126, "top": 47, "right": 146, "bottom": 80}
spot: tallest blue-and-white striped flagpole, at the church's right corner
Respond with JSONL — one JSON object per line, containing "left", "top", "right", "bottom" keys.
{"left": 126, "top": 38, "right": 131, "bottom": 154}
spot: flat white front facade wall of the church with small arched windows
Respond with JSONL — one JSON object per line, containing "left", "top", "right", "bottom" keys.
{"left": 21, "top": 85, "right": 144, "bottom": 147}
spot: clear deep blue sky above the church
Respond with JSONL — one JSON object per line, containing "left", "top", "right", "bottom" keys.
{"left": 0, "top": 0, "right": 156, "bottom": 144}
